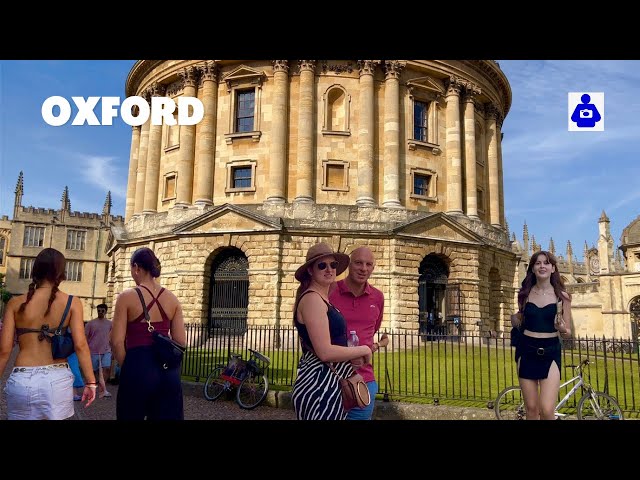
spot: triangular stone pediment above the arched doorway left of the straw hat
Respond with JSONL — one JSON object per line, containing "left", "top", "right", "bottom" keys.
{"left": 173, "top": 203, "right": 282, "bottom": 233}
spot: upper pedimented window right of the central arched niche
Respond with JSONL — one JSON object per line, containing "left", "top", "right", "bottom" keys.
{"left": 405, "top": 77, "right": 445, "bottom": 154}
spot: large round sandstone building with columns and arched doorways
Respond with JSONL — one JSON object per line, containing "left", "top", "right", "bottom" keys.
{"left": 108, "top": 60, "right": 519, "bottom": 334}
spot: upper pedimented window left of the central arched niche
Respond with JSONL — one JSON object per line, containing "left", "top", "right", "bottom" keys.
{"left": 224, "top": 65, "right": 265, "bottom": 145}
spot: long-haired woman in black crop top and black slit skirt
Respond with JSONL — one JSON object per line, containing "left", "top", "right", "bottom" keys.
{"left": 511, "top": 251, "right": 571, "bottom": 420}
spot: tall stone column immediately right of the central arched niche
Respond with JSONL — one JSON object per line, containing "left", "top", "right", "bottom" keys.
{"left": 356, "top": 60, "right": 380, "bottom": 206}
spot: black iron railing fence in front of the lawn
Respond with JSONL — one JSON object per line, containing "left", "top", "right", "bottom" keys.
{"left": 182, "top": 325, "right": 640, "bottom": 414}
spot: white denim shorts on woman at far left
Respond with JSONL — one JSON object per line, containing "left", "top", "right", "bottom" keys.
{"left": 4, "top": 363, "right": 75, "bottom": 420}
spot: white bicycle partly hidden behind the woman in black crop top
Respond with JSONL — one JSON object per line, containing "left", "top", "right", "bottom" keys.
{"left": 494, "top": 359, "right": 623, "bottom": 420}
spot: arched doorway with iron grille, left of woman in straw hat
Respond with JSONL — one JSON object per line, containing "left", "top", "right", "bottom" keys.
{"left": 209, "top": 247, "right": 249, "bottom": 335}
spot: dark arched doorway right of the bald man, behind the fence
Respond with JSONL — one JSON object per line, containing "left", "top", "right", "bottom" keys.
{"left": 418, "top": 253, "right": 449, "bottom": 340}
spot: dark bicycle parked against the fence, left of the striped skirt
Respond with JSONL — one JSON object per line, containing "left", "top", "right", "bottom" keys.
{"left": 204, "top": 349, "right": 271, "bottom": 410}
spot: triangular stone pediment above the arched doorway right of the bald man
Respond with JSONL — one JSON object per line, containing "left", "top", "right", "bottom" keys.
{"left": 394, "top": 213, "right": 484, "bottom": 244}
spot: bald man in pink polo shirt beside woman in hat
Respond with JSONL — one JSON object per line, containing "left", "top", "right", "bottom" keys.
{"left": 329, "top": 247, "right": 389, "bottom": 420}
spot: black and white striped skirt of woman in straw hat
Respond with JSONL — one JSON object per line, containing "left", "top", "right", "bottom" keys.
{"left": 291, "top": 352, "right": 353, "bottom": 420}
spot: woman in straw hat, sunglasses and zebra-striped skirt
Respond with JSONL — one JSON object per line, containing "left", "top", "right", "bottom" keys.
{"left": 292, "top": 243, "right": 371, "bottom": 420}
